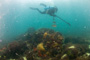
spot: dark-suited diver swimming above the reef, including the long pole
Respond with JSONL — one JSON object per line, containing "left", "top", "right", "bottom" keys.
{"left": 30, "top": 3, "right": 71, "bottom": 26}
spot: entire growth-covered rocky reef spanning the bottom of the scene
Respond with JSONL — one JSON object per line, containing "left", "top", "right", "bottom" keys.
{"left": 0, "top": 28, "right": 90, "bottom": 60}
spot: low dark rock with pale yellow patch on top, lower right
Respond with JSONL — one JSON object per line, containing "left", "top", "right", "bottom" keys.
{"left": 64, "top": 43, "right": 89, "bottom": 59}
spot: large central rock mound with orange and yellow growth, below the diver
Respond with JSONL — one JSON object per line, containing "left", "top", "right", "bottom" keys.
{"left": 21, "top": 28, "right": 63, "bottom": 60}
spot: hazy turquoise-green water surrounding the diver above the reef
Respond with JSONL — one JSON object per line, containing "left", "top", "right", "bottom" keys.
{"left": 0, "top": 0, "right": 90, "bottom": 41}
